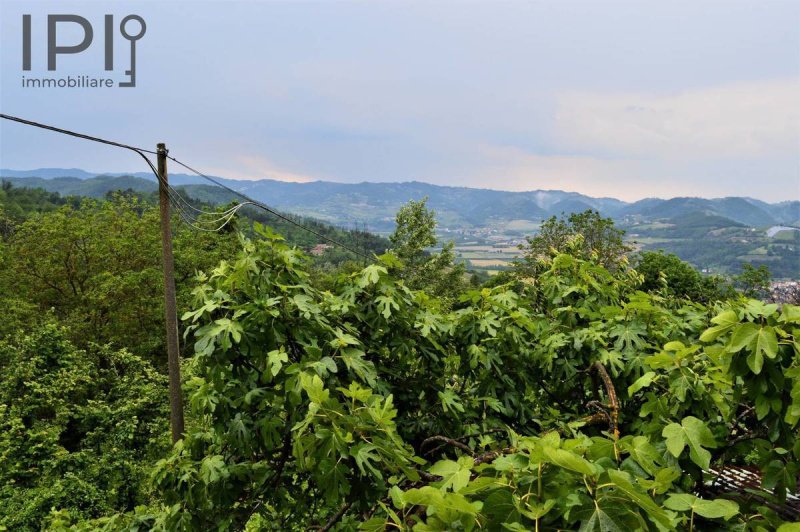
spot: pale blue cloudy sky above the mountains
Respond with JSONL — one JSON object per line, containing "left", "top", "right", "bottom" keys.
{"left": 0, "top": 0, "right": 800, "bottom": 202}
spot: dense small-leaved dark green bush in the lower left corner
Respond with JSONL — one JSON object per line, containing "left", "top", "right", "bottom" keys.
{"left": 0, "top": 325, "right": 168, "bottom": 530}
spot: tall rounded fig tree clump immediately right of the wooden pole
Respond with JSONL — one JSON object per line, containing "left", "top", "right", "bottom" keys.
{"left": 136, "top": 226, "right": 415, "bottom": 529}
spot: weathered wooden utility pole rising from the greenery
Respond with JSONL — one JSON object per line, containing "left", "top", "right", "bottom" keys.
{"left": 156, "top": 143, "right": 183, "bottom": 443}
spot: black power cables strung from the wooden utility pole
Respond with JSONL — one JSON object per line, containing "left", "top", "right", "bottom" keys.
{"left": 0, "top": 113, "right": 370, "bottom": 259}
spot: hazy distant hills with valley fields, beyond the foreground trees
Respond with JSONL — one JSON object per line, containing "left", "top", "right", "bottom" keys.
{"left": 0, "top": 169, "right": 800, "bottom": 279}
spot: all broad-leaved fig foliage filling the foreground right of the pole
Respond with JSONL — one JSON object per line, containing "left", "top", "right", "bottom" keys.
{"left": 115, "top": 229, "right": 800, "bottom": 530}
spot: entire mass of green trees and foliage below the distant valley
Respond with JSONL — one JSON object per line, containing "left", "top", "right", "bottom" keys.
{"left": 0, "top": 186, "right": 800, "bottom": 532}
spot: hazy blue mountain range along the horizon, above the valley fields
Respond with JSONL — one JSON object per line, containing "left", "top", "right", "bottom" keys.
{"left": 0, "top": 168, "right": 800, "bottom": 231}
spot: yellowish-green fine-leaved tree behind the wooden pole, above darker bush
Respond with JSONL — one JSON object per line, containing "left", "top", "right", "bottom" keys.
{"left": 0, "top": 197, "right": 236, "bottom": 364}
